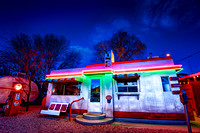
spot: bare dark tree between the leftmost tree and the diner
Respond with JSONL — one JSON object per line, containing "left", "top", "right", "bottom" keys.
{"left": 34, "top": 34, "right": 81, "bottom": 101}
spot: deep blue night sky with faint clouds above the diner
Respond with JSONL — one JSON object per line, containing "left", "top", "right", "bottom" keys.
{"left": 0, "top": 0, "right": 200, "bottom": 74}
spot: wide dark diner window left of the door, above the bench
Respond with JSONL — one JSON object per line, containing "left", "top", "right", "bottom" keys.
{"left": 52, "top": 82, "right": 81, "bottom": 95}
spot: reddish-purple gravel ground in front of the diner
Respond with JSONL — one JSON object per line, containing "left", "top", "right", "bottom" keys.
{"left": 0, "top": 106, "right": 198, "bottom": 133}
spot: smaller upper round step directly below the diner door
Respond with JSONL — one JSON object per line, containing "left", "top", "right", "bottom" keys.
{"left": 83, "top": 113, "right": 106, "bottom": 120}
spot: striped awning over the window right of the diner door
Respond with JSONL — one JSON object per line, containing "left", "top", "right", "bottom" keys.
{"left": 113, "top": 73, "right": 140, "bottom": 81}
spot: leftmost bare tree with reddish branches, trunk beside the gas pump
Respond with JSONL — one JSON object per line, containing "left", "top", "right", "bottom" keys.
{"left": 0, "top": 33, "right": 45, "bottom": 111}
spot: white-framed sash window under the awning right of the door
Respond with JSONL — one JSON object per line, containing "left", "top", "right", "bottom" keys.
{"left": 117, "top": 79, "right": 138, "bottom": 92}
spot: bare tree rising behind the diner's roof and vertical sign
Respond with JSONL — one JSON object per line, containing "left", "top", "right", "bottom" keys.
{"left": 94, "top": 30, "right": 146, "bottom": 62}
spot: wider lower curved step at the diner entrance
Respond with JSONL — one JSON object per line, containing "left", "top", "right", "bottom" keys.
{"left": 76, "top": 115, "right": 113, "bottom": 125}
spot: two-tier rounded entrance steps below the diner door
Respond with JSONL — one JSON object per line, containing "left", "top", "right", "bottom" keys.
{"left": 76, "top": 113, "right": 113, "bottom": 125}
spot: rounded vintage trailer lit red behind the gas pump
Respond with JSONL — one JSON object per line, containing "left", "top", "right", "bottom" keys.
{"left": 0, "top": 76, "right": 38, "bottom": 104}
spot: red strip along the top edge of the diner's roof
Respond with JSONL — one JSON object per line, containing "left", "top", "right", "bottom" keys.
{"left": 86, "top": 57, "right": 172, "bottom": 67}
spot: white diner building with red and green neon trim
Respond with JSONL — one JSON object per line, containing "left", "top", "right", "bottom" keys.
{"left": 43, "top": 53, "right": 185, "bottom": 120}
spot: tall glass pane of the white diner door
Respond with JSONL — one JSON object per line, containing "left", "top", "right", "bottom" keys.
{"left": 90, "top": 79, "right": 100, "bottom": 102}
